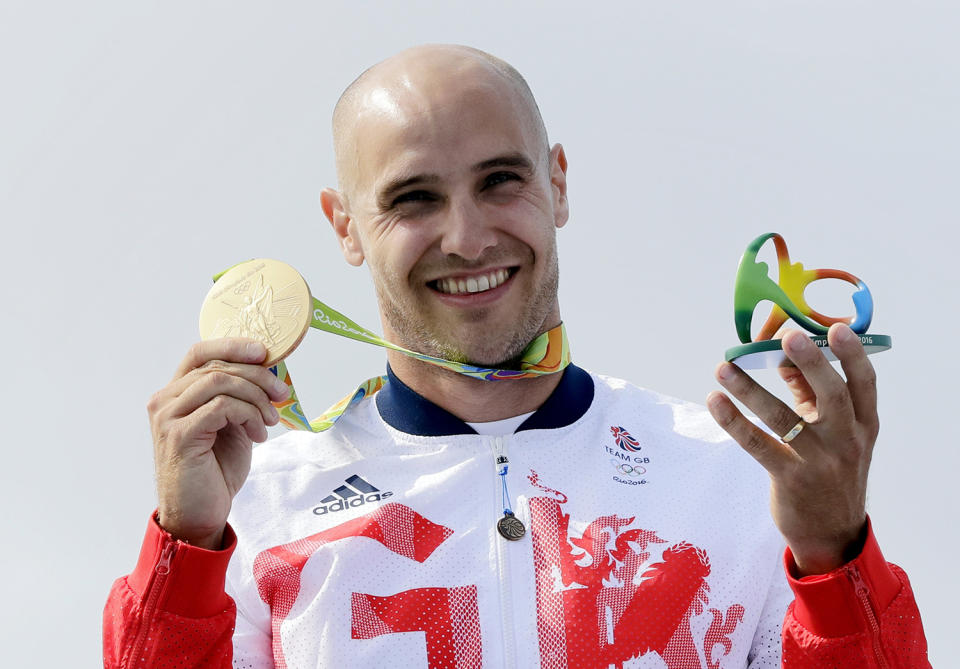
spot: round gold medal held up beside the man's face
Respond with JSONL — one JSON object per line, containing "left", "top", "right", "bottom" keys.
{"left": 200, "top": 258, "right": 313, "bottom": 367}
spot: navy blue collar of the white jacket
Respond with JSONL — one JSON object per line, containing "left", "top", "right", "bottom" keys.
{"left": 374, "top": 364, "right": 593, "bottom": 437}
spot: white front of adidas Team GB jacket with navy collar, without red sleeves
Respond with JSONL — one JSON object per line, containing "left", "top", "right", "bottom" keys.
{"left": 227, "top": 366, "right": 793, "bottom": 669}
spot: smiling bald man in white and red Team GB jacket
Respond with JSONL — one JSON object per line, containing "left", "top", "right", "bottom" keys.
{"left": 104, "top": 46, "right": 927, "bottom": 668}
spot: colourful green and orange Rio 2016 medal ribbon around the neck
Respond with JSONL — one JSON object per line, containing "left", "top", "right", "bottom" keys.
{"left": 214, "top": 260, "right": 570, "bottom": 432}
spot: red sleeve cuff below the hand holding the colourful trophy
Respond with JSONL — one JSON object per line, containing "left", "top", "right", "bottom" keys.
{"left": 782, "top": 520, "right": 930, "bottom": 669}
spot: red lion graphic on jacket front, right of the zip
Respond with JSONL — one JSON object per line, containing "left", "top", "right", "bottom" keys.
{"left": 530, "top": 472, "right": 744, "bottom": 669}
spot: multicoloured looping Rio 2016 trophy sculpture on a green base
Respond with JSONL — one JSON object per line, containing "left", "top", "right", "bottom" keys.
{"left": 724, "top": 232, "right": 892, "bottom": 369}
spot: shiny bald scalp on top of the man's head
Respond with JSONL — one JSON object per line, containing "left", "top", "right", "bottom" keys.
{"left": 333, "top": 44, "right": 549, "bottom": 199}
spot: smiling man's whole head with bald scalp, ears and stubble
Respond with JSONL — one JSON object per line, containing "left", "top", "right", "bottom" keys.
{"left": 322, "top": 47, "right": 567, "bottom": 365}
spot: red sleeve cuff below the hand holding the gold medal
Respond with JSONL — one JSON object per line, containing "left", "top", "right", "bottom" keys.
{"left": 103, "top": 515, "right": 237, "bottom": 669}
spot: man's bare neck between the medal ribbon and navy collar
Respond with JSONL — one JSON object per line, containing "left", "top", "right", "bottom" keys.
{"left": 387, "top": 351, "right": 562, "bottom": 422}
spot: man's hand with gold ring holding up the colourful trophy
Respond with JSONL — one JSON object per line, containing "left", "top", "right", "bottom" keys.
{"left": 707, "top": 324, "right": 880, "bottom": 575}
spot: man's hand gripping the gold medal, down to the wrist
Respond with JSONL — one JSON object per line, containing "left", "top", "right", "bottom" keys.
{"left": 147, "top": 338, "right": 289, "bottom": 550}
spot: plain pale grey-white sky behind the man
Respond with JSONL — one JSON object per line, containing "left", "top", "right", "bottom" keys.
{"left": 0, "top": 0, "right": 960, "bottom": 667}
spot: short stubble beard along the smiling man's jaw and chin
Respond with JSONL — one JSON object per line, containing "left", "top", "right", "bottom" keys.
{"left": 374, "top": 247, "right": 560, "bottom": 369}
